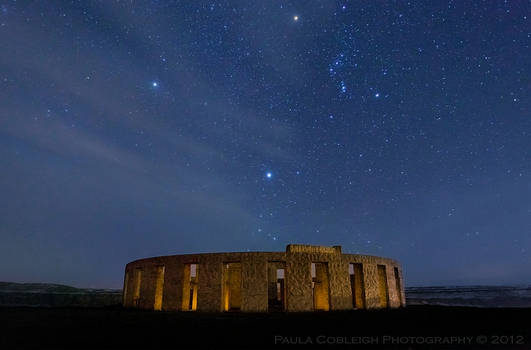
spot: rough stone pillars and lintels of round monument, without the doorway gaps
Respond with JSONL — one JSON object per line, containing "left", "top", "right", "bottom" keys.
{"left": 123, "top": 245, "right": 405, "bottom": 312}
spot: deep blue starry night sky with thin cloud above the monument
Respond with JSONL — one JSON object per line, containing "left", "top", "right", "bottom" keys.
{"left": 0, "top": 0, "right": 531, "bottom": 288}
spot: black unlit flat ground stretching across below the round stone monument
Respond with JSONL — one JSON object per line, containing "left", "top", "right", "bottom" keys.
{"left": 0, "top": 306, "right": 531, "bottom": 350}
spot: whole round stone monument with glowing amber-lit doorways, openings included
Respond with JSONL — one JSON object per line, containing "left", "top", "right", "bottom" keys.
{"left": 123, "top": 244, "right": 405, "bottom": 312}
